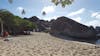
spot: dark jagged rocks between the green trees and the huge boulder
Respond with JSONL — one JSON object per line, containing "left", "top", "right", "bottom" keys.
{"left": 24, "top": 16, "right": 50, "bottom": 32}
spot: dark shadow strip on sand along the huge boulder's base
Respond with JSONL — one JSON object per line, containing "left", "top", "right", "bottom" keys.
{"left": 50, "top": 34, "right": 97, "bottom": 44}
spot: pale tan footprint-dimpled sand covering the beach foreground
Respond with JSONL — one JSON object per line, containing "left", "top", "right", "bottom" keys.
{"left": 0, "top": 32, "right": 100, "bottom": 56}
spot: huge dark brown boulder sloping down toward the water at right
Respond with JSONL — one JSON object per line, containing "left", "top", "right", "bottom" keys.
{"left": 50, "top": 16, "right": 96, "bottom": 39}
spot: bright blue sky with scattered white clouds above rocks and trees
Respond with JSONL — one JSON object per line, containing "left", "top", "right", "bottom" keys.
{"left": 0, "top": 0, "right": 100, "bottom": 27}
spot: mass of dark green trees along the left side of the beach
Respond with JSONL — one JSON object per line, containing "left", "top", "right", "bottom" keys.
{"left": 0, "top": 9, "right": 37, "bottom": 34}
